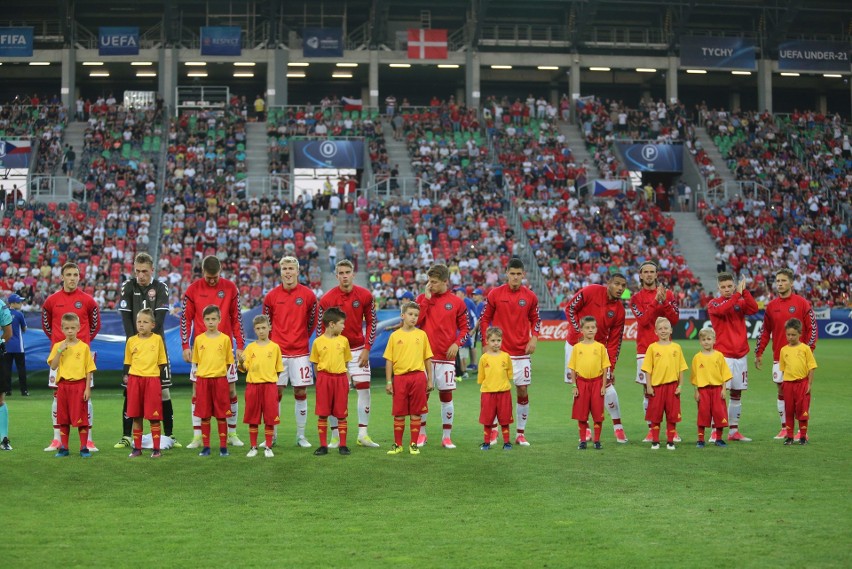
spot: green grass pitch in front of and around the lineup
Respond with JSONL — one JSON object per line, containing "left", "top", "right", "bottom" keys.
{"left": 0, "top": 341, "right": 852, "bottom": 568}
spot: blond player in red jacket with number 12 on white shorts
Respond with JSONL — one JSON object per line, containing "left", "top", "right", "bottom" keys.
{"left": 263, "top": 256, "right": 317, "bottom": 448}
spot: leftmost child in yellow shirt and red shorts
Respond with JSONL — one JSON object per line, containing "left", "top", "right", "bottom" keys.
{"left": 47, "top": 312, "right": 97, "bottom": 458}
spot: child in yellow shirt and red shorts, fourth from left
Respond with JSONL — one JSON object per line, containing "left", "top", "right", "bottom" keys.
{"left": 239, "top": 314, "right": 284, "bottom": 458}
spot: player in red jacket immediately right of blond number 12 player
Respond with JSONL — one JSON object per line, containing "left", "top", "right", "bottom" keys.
{"left": 317, "top": 259, "right": 379, "bottom": 448}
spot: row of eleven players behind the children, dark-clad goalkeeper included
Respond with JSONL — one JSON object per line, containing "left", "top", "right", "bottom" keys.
{"left": 31, "top": 253, "right": 817, "bottom": 451}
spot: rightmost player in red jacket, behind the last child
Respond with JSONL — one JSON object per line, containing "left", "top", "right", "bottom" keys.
{"left": 754, "top": 268, "right": 818, "bottom": 439}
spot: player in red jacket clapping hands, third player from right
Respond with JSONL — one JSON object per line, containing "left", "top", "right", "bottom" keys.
{"left": 630, "top": 261, "right": 680, "bottom": 443}
